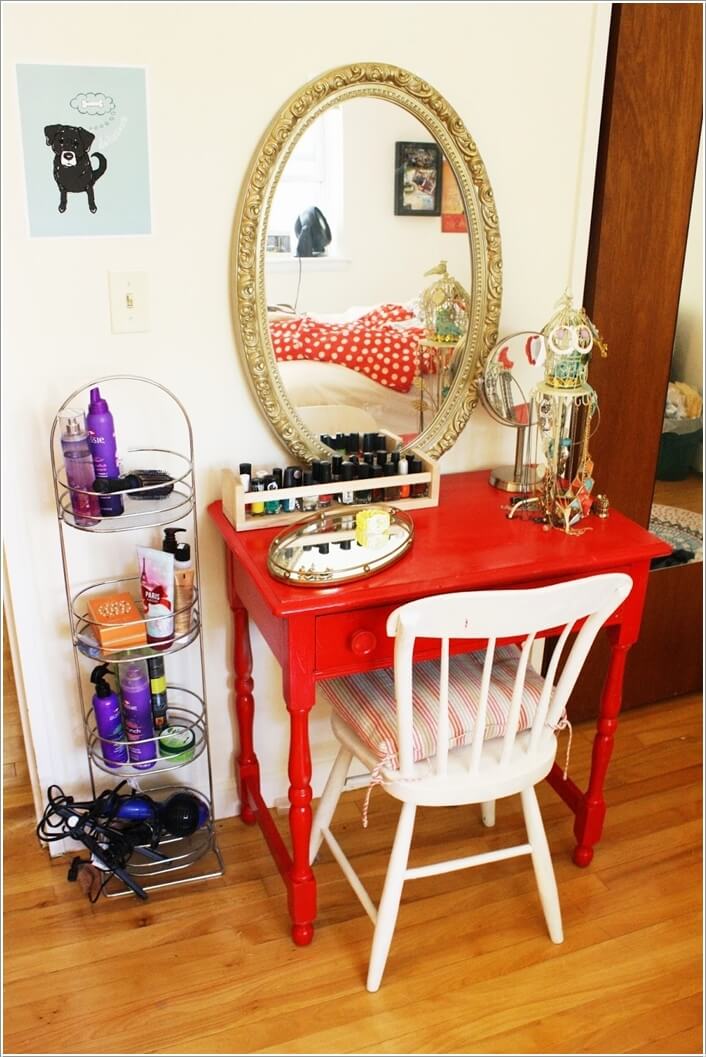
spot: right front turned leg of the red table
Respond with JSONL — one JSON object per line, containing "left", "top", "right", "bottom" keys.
{"left": 574, "top": 628, "right": 630, "bottom": 866}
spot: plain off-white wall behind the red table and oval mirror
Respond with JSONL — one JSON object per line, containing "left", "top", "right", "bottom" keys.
{"left": 2, "top": 2, "right": 610, "bottom": 815}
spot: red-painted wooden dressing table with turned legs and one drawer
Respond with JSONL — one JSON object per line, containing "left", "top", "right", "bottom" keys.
{"left": 208, "top": 470, "right": 671, "bottom": 945}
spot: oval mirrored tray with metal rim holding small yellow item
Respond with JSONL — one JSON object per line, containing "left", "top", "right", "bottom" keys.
{"left": 267, "top": 503, "right": 414, "bottom": 588}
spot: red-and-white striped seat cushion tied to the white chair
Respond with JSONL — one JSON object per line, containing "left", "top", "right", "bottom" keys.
{"left": 319, "top": 646, "right": 544, "bottom": 766}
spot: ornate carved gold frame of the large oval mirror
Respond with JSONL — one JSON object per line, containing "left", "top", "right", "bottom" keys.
{"left": 230, "top": 62, "right": 502, "bottom": 460}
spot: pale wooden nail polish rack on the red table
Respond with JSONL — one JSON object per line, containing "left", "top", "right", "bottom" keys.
{"left": 221, "top": 430, "right": 439, "bottom": 532}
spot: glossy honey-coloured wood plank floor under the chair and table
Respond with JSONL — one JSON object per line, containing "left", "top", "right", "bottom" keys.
{"left": 3, "top": 663, "right": 703, "bottom": 1054}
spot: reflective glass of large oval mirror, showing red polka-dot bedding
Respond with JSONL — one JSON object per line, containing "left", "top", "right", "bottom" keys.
{"left": 265, "top": 98, "right": 471, "bottom": 440}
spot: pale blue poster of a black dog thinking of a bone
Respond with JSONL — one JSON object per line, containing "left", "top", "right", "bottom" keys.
{"left": 17, "top": 63, "right": 151, "bottom": 237}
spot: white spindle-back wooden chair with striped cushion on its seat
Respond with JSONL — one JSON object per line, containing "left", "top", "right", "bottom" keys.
{"left": 310, "top": 573, "right": 632, "bottom": 991}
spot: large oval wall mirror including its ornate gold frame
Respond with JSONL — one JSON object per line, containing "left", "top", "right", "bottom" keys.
{"left": 233, "top": 63, "right": 501, "bottom": 459}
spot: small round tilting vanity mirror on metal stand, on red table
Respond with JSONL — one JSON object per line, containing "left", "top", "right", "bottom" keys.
{"left": 481, "top": 331, "right": 546, "bottom": 494}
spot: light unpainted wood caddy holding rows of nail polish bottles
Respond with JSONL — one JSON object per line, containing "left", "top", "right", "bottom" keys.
{"left": 221, "top": 434, "right": 439, "bottom": 532}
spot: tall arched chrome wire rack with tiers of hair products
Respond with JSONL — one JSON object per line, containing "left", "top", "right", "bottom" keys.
{"left": 50, "top": 375, "right": 224, "bottom": 897}
